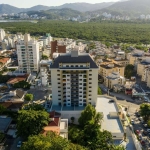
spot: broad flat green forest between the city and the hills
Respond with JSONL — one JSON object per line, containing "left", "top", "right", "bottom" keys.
{"left": 0, "top": 20, "right": 150, "bottom": 44}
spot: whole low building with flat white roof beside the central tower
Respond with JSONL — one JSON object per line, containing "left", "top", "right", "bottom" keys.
{"left": 96, "top": 95, "right": 125, "bottom": 140}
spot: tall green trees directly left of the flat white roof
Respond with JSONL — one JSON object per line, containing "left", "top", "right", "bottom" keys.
{"left": 69, "top": 104, "right": 124, "bottom": 150}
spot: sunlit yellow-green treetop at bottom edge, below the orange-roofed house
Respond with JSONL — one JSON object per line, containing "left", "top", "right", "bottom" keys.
{"left": 21, "top": 132, "right": 86, "bottom": 150}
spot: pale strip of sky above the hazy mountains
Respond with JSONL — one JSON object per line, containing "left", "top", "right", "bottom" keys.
{"left": 0, "top": 0, "right": 118, "bottom": 8}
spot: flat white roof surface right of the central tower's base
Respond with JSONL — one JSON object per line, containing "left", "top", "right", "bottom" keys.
{"left": 96, "top": 96, "right": 124, "bottom": 133}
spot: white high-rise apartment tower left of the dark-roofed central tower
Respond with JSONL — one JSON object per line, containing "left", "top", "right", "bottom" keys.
{"left": 17, "top": 34, "right": 40, "bottom": 73}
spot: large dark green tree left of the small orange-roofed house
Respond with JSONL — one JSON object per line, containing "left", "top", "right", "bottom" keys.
{"left": 17, "top": 110, "right": 50, "bottom": 138}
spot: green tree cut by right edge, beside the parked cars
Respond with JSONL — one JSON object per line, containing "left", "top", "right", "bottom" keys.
{"left": 140, "top": 103, "right": 150, "bottom": 121}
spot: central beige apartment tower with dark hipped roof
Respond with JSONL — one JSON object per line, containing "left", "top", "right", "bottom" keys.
{"left": 50, "top": 51, "right": 98, "bottom": 107}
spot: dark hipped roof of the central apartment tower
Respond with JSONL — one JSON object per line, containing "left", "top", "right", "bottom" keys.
{"left": 51, "top": 54, "right": 98, "bottom": 69}
